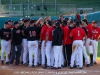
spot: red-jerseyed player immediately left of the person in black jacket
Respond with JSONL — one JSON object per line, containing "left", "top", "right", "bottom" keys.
{"left": 44, "top": 21, "right": 54, "bottom": 69}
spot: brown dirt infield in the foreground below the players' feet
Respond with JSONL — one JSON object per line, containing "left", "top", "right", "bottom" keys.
{"left": 0, "top": 61, "right": 100, "bottom": 75}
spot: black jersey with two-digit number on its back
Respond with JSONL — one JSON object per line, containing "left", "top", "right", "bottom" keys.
{"left": 25, "top": 26, "right": 39, "bottom": 41}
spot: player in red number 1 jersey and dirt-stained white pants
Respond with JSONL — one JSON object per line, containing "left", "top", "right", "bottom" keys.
{"left": 70, "top": 20, "right": 86, "bottom": 69}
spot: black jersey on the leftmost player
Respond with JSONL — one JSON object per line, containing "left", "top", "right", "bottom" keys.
{"left": 0, "top": 28, "right": 11, "bottom": 41}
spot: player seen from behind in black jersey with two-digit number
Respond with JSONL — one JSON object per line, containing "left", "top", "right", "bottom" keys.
{"left": 25, "top": 20, "right": 39, "bottom": 67}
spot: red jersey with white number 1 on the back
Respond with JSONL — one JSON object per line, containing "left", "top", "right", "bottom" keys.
{"left": 70, "top": 27, "right": 86, "bottom": 40}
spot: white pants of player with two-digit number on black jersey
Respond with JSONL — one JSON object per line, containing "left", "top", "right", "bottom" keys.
{"left": 28, "top": 41, "right": 38, "bottom": 66}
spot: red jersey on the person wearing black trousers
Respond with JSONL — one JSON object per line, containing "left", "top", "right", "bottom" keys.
{"left": 63, "top": 26, "right": 72, "bottom": 45}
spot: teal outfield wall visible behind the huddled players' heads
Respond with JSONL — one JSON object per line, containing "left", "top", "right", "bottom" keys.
{"left": 0, "top": 11, "right": 100, "bottom": 28}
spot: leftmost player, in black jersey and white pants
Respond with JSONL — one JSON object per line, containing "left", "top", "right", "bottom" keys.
{"left": 0, "top": 22, "right": 11, "bottom": 64}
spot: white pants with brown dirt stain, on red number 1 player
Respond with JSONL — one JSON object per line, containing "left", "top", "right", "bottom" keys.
{"left": 70, "top": 40, "right": 83, "bottom": 67}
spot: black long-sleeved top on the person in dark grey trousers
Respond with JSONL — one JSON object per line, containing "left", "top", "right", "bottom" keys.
{"left": 11, "top": 28, "right": 22, "bottom": 45}
